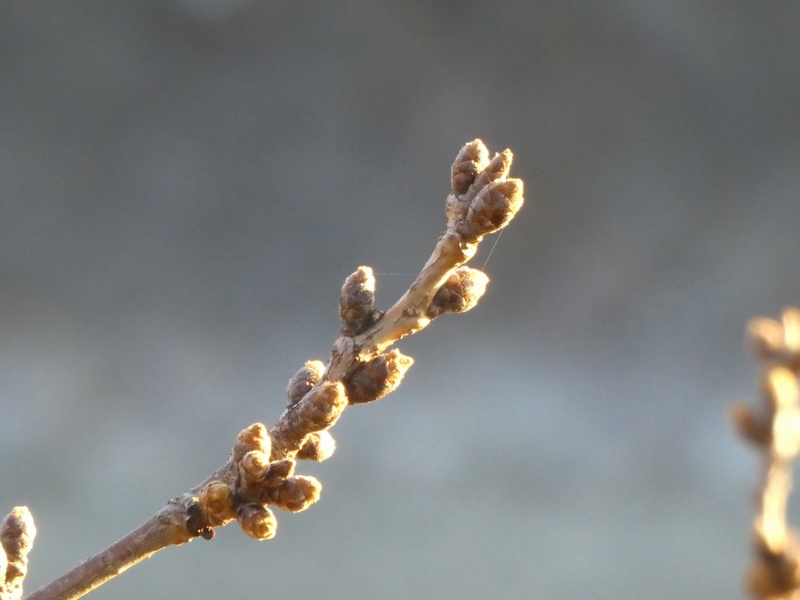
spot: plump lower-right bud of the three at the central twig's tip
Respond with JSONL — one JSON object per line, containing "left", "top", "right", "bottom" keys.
{"left": 458, "top": 179, "right": 523, "bottom": 242}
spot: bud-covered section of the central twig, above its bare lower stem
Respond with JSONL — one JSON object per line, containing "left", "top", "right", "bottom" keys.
{"left": 186, "top": 140, "right": 523, "bottom": 539}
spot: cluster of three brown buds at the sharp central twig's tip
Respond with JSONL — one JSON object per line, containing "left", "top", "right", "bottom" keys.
{"left": 445, "top": 140, "right": 523, "bottom": 244}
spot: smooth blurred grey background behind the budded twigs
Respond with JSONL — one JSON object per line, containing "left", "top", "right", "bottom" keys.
{"left": 0, "top": 0, "right": 800, "bottom": 600}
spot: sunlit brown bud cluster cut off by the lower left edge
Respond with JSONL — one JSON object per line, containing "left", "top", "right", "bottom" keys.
{"left": 0, "top": 506, "right": 36, "bottom": 600}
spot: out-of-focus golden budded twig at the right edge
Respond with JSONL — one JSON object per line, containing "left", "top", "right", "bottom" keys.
{"left": 731, "top": 309, "right": 800, "bottom": 599}
